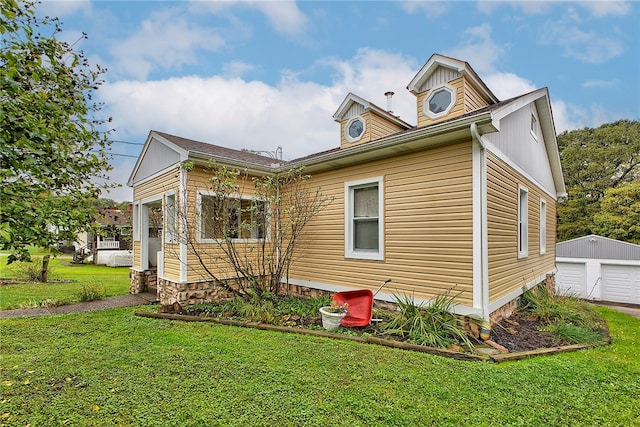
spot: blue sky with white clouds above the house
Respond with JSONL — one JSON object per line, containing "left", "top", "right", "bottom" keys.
{"left": 39, "top": 0, "right": 640, "bottom": 200}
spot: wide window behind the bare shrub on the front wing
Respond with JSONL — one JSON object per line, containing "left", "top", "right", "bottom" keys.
{"left": 198, "top": 193, "right": 267, "bottom": 243}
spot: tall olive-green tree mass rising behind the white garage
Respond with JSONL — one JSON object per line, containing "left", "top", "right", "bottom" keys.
{"left": 558, "top": 120, "right": 640, "bottom": 240}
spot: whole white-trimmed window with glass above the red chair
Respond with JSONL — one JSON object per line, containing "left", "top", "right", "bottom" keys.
{"left": 344, "top": 176, "right": 384, "bottom": 260}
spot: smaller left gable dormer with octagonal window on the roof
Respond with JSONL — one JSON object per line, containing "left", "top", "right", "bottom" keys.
{"left": 333, "top": 93, "right": 412, "bottom": 148}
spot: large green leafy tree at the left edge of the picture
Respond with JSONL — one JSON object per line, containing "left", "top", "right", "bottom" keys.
{"left": 0, "top": 0, "right": 110, "bottom": 262}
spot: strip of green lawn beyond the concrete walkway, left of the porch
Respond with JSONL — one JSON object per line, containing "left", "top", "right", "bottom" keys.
{"left": 0, "top": 256, "right": 129, "bottom": 310}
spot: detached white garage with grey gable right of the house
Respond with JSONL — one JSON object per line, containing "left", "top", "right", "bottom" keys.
{"left": 556, "top": 234, "right": 640, "bottom": 304}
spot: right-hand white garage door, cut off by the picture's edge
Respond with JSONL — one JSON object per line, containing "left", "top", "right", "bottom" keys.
{"left": 601, "top": 264, "right": 640, "bottom": 304}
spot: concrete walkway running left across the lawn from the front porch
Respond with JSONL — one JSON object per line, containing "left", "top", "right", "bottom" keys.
{"left": 0, "top": 293, "right": 156, "bottom": 319}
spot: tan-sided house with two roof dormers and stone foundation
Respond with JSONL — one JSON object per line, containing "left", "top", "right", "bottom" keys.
{"left": 129, "top": 55, "right": 565, "bottom": 320}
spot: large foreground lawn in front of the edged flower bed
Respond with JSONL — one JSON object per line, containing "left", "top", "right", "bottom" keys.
{"left": 0, "top": 306, "right": 640, "bottom": 426}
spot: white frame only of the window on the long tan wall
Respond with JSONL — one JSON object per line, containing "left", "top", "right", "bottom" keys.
{"left": 344, "top": 176, "right": 384, "bottom": 260}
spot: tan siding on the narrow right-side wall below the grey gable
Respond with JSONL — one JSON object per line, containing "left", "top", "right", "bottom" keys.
{"left": 487, "top": 153, "right": 556, "bottom": 302}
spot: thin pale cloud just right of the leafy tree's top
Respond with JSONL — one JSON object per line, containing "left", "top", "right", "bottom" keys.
{"left": 109, "top": 9, "right": 224, "bottom": 79}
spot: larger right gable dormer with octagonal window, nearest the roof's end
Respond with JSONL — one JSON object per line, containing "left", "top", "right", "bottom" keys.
{"left": 407, "top": 54, "right": 498, "bottom": 127}
